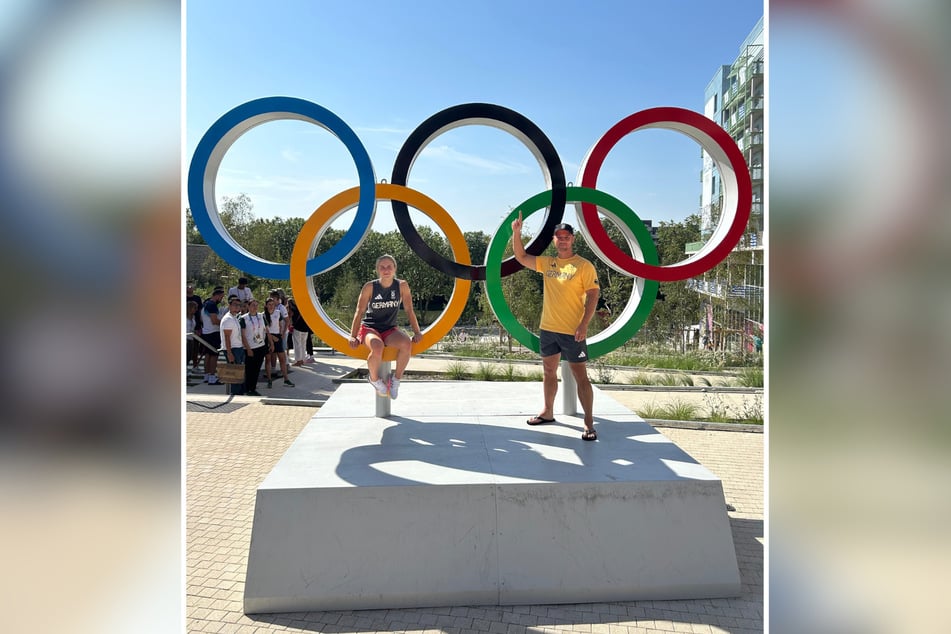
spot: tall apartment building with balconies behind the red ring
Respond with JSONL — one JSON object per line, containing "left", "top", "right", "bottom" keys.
{"left": 686, "top": 18, "right": 765, "bottom": 351}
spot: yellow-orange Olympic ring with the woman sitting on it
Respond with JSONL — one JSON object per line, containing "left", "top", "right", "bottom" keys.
{"left": 290, "top": 183, "right": 472, "bottom": 361}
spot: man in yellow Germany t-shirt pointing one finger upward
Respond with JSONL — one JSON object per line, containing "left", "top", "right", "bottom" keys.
{"left": 512, "top": 212, "right": 601, "bottom": 440}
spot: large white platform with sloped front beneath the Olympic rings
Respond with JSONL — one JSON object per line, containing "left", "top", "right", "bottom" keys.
{"left": 244, "top": 381, "right": 740, "bottom": 613}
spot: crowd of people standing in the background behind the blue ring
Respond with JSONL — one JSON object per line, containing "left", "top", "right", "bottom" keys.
{"left": 185, "top": 277, "right": 314, "bottom": 396}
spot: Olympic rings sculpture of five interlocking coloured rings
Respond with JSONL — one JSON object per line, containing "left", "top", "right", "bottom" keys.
{"left": 187, "top": 97, "right": 752, "bottom": 360}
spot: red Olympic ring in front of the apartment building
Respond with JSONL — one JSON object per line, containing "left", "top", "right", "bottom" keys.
{"left": 578, "top": 107, "right": 753, "bottom": 282}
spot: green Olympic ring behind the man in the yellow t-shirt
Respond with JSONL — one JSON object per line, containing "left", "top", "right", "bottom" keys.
{"left": 485, "top": 187, "right": 659, "bottom": 359}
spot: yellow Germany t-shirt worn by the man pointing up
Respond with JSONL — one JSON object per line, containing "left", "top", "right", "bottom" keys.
{"left": 535, "top": 255, "right": 600, "bottom": 335}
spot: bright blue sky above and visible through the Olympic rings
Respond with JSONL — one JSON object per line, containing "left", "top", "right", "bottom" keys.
{"left": 185, "top": 0, "right": 763, "bottom": 233}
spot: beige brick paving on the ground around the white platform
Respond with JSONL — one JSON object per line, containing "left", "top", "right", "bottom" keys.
{"left": 186, "top": 354, "right": 764, "bottom": 634}
